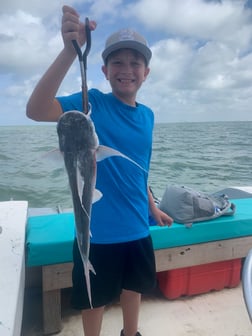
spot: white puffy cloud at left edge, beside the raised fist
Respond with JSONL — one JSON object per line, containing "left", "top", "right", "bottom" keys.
{"left": 0, "top": 10, "right": 62, "bottom": 76}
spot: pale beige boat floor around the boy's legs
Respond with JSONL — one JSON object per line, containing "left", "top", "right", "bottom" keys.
{"left": 22, "top": 286, "right": 252, "bottom": 336}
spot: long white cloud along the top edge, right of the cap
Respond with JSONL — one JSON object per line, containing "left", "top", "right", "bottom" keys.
{"left": 128, "top": 0, "right": 251, "bottom": 40}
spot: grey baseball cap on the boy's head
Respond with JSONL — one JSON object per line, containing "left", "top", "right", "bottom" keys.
{"left": 102, "top": 29, "right": 152, "bottom": 64}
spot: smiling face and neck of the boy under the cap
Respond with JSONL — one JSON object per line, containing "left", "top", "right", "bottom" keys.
{"left": 102, "top": 49, "right": 150, "bottom": 106}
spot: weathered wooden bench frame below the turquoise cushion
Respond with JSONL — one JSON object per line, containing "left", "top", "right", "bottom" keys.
{"left": 39, "top": 236, "right": 252, "bottom": 334}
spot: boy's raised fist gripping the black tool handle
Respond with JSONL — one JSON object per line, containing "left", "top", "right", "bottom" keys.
{"left": 61, "top": 6, "right": 96, "bottom": 54}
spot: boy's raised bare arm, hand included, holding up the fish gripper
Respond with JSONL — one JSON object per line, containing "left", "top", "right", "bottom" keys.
{"left": 26, "top": 6, "right": 96, "bottom": 121}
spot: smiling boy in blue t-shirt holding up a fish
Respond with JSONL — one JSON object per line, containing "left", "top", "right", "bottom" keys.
{"left": 27, "top": 6, "right": 172, "bottom": 336}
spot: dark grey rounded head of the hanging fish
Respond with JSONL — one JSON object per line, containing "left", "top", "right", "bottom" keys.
{"left": 57, "top": 111, "right": 98, "bottom": 153}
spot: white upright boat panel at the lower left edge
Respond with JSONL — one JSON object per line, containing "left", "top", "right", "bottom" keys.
{"left": 0, "top": 201, "right": 28, "bottom": 336}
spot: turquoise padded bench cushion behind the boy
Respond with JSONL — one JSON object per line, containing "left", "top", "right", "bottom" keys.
{"left": 26, "top": 198, "right": 252, "bottom": 266}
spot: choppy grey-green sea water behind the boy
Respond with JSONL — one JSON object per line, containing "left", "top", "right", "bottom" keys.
{"left": 0, "top": 122, "right": 252, "bottom": 208}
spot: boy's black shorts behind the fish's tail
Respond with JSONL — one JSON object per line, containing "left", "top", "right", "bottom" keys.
{"left": 72, "top": 236, "right": 156, "bottom": 309}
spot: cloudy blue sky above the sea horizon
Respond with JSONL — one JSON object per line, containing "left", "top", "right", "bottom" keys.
{"left": 0, "top": 0, "right": 252, "bottom": 125}
